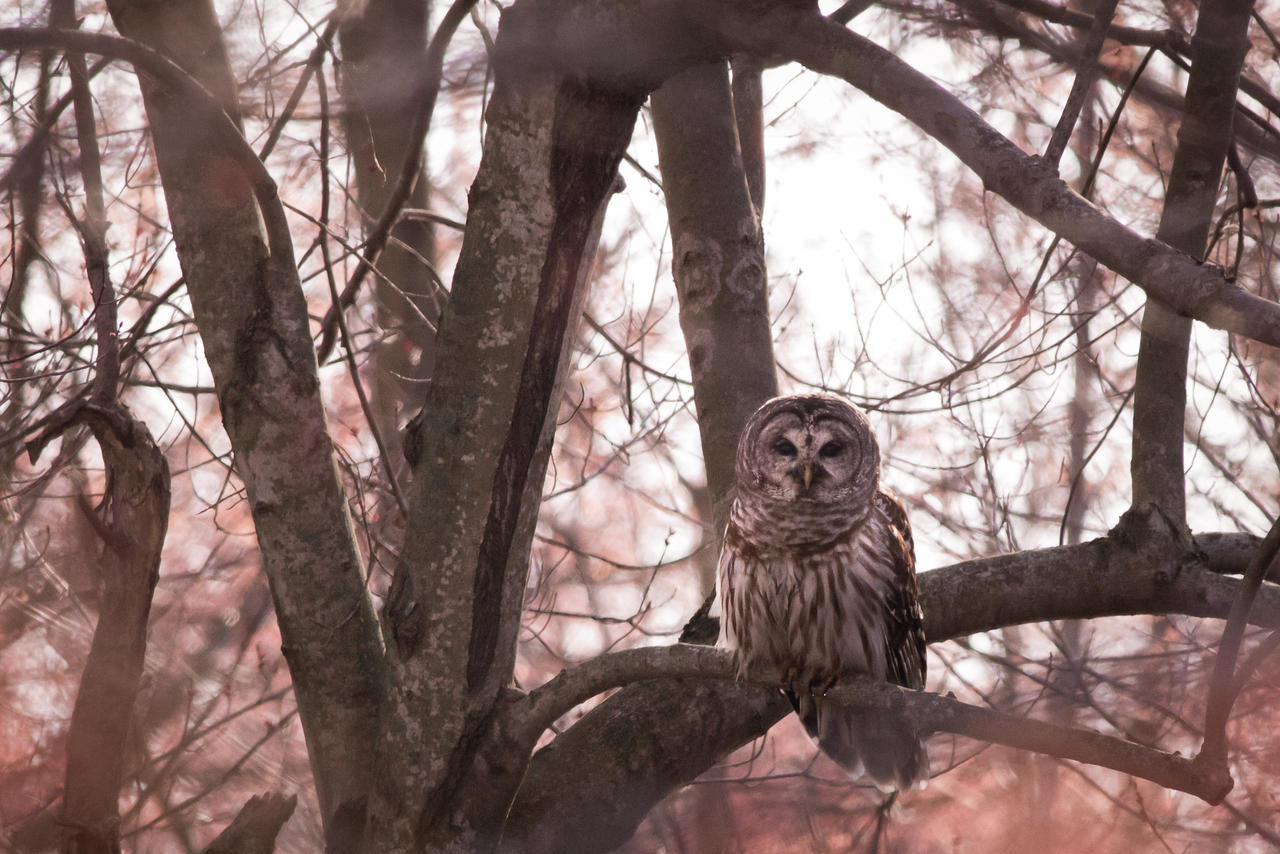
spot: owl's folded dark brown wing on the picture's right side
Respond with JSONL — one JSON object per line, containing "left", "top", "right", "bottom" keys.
{"left": 876, "top": 489, "right": 925, "bottom": 689}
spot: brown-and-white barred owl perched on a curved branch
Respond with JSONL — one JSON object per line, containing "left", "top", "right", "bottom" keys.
{"left": 717, "top": 394, "right": 929, "bottom": 791}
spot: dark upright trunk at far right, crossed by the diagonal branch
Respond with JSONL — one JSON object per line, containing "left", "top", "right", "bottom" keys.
{"left": 1130, "top": 0, "right": 1253, "bottom": 524}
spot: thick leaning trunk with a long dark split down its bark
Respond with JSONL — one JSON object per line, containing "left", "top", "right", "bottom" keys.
{"left": 369, "top": 10, "right": 643, "bottom": 850}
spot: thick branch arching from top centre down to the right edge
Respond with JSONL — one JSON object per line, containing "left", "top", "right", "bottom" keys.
{"left": 476, "top": 0, "right": 1280, "bottom": 346}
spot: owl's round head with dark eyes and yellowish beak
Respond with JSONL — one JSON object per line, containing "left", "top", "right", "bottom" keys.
{"left": 737, "top": 394, "right": 879, "bottom": 510}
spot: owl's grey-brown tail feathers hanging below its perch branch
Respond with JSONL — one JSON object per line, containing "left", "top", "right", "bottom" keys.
{"left": 797, "top": 698, "right": 929, "bottom": 791}
